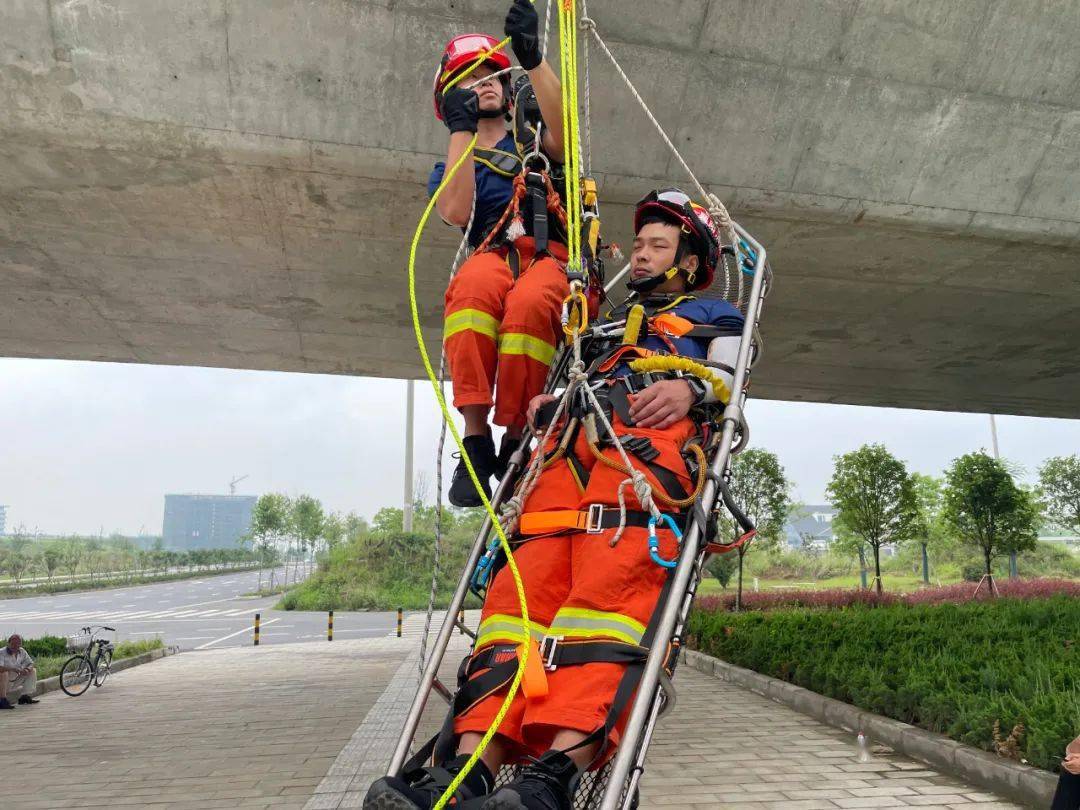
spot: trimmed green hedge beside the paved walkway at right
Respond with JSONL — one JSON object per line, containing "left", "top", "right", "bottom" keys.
{"left": 688, "top": 596, "right": 1080, "bottom": 770}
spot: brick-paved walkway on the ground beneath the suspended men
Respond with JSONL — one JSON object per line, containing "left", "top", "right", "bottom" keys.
{"left": 0, "top": 618, "right": 1016, "bottom": 810}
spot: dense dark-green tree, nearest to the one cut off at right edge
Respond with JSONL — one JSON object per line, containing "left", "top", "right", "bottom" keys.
{"left": 943, "top": 453, "right": 1039, "bottom": 593}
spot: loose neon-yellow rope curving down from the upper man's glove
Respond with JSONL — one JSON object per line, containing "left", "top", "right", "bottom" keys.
{"left": 408, "top": 135, "right": 531, "bottom": 810}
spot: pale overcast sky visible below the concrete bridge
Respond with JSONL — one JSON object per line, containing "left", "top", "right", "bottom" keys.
{"left": 0, "top": 359, "right": 1080, "bottom": 535}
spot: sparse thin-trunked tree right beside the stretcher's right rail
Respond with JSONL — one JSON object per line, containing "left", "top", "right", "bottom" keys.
{"left": 714, "top": 448, "right": 791, "bottom": 610}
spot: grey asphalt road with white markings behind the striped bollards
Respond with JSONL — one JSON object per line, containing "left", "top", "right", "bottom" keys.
{"left": 0, "top": 571, "right": 397, "bottom": 649}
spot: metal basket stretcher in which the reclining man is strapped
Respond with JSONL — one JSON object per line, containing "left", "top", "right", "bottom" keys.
{"left": 387, "top": 222, "right": 771, "bottom": 810}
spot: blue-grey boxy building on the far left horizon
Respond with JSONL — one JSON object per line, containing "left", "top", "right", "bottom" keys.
{"left": 161, "top": 495, "right": 256, "bottom": 551}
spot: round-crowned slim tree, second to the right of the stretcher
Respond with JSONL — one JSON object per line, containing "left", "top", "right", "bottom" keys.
{"left": 826, "top": 444, "right": 917, "bottom": 594}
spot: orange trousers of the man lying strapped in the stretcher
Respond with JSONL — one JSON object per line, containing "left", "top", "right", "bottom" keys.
{"left": 454, "top": 418, "right": 696, "bottom": 757}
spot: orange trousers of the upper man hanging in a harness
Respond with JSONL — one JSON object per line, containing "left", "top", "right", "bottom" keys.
{"left": 443, "top": 237, "right": 569, "bottom": 429}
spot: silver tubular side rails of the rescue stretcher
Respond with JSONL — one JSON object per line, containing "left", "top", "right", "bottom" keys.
{"left": 387, "top": 222, "right": 771, "bottom": 810}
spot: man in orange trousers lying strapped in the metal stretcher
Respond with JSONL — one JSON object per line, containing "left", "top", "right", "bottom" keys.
{"left": 365, "top": 189, "right": 743, "bottom": 810}
